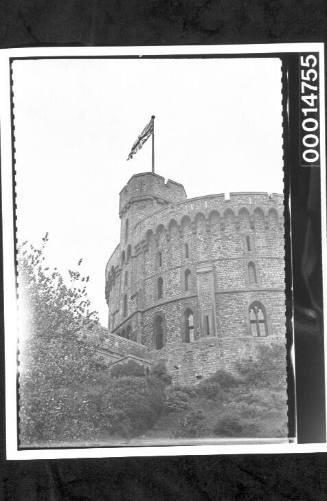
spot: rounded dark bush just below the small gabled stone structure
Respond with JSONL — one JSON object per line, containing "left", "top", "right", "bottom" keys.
{"left": 99, "top": 376, "right": 165, "bottom": 436}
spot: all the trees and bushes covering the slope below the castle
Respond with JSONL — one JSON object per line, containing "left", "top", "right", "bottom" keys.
{"left": 19, "top": 236, "right": 287, "bottom": 446}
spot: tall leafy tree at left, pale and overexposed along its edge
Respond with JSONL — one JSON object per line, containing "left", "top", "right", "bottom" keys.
{"left": 18, "top": 234, "right": 99, "bottom": 445}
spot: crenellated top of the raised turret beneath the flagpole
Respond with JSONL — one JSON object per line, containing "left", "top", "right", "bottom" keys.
{"left": 119, "top": 172, "right": 186, "bottom": 217}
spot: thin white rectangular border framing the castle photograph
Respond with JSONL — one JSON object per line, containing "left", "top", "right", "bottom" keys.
{"left": 0, "top": 43, "right": 327, "bottom": 459}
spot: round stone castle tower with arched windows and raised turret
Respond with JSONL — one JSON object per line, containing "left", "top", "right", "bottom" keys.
{"left": 106, "top": 172, "right": 285, "bottom": 384}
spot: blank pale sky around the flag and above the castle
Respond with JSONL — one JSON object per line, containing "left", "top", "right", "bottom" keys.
{"left": 13, "top": 58, "right": 283, "bottom": 326}
